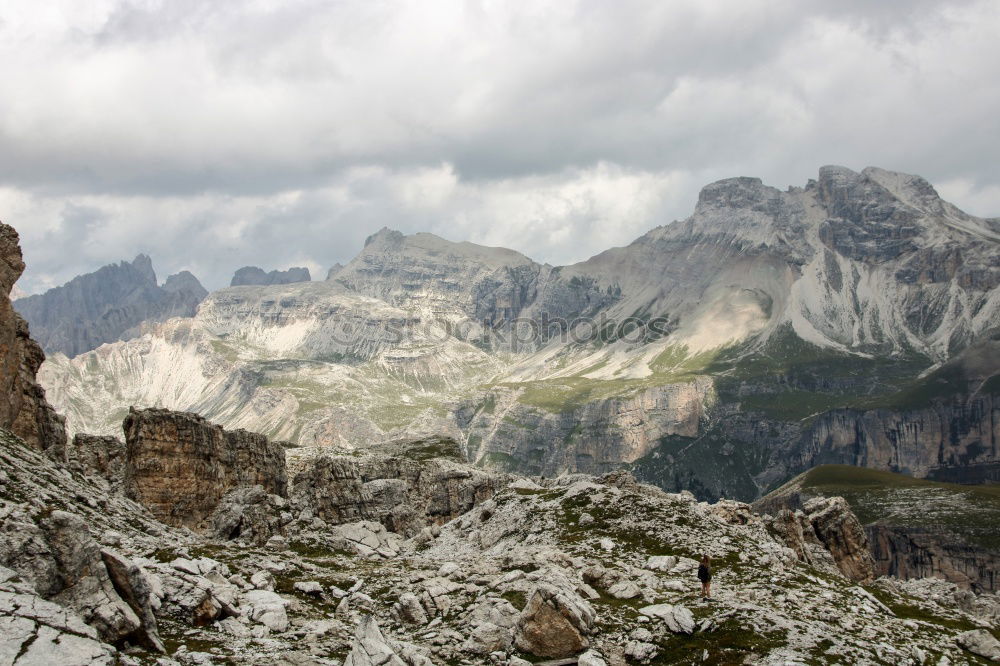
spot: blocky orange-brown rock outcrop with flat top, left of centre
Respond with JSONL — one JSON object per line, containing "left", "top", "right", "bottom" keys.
{"left": 123, "top": 409, "right": 287, "bottom": 529}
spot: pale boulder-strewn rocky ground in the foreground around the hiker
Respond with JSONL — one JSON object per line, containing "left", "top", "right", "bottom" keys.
{"left": 0, "top": 410, "right": 1000, "bottom": 666}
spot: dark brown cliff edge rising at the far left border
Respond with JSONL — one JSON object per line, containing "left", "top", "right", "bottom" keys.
{"left": 0, "top": 223, "right": 66, "bottom": 458}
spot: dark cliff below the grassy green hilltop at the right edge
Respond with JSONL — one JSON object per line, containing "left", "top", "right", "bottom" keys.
{"left": 865, "top": 525, "right": 1000, "bottom": 592}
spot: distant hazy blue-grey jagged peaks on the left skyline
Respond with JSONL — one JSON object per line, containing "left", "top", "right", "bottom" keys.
{"left": 15, "top": 254, "right": 208, "bottom": 357}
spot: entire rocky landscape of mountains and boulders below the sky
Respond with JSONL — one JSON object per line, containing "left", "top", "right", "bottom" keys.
{"left": 0, "top": 162, "right": 1000, "bottom": 666}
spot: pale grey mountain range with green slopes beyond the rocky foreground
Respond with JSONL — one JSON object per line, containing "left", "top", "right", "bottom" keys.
{"left": 23, "top": 167, "right": 1000, "bottom": 500}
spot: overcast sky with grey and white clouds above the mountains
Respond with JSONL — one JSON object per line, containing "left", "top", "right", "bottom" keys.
{"left": 0, "top": 0, "right": 1000, "bottom": 292}
